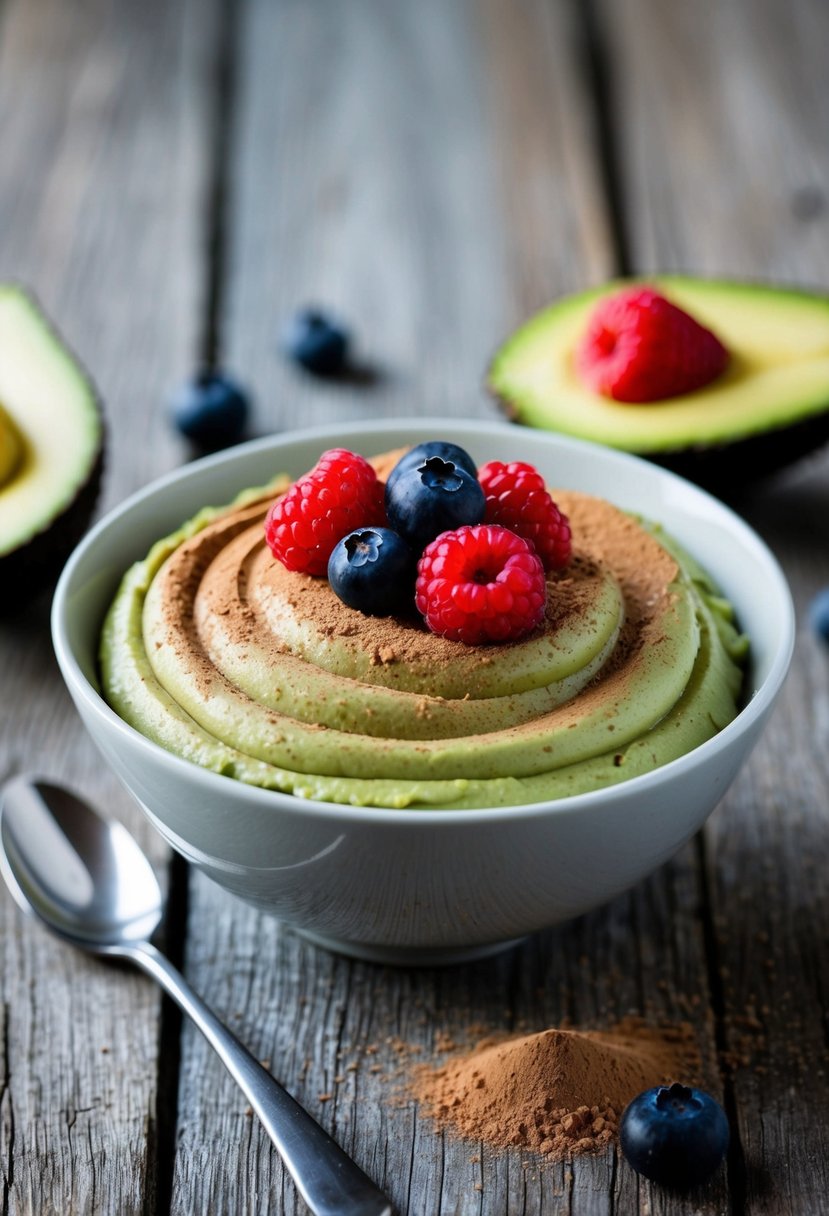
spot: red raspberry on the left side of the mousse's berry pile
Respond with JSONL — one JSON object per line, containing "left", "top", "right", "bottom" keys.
{"left": 265, "top": 447, "right": 385, "bottom": 575}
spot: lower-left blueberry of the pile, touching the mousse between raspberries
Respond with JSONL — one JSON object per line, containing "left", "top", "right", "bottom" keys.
{"left": 328, "top": 528, "right": 415, "bottom": 617}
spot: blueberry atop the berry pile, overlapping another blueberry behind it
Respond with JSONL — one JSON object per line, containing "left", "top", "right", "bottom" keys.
{"left": 385, "top": 456, "right": 486, "bottom": 553}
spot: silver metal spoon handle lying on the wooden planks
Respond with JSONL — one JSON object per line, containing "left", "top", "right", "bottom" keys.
{"left": 125, "top": 942, "right": 393, "bottom": 1216}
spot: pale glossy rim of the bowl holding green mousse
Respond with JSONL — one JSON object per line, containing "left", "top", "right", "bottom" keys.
{"left": 51, "top": 417, "right": 795, "bottom": 828}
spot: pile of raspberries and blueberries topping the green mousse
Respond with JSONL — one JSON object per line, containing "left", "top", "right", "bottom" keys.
{"left": 265, "top": 440, "right": 570, "bottom": 644}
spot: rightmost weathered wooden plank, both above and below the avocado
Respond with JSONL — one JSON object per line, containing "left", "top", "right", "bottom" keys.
{"left": 603, "top": 0, "right": 829, "bottom": 1216}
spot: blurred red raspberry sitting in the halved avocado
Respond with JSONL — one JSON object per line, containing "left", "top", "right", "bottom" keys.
{"left": 576, "top": 287, "right": 729, "bottom": 401}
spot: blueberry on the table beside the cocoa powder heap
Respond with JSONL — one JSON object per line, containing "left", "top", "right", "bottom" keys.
{"left": 619, "top": 1083, "right": 728, "bottom": 1189}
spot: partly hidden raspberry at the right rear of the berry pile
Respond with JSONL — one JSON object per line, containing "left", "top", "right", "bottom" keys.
{"left": 478, "top": 460, "right": 573, "bottom": 570}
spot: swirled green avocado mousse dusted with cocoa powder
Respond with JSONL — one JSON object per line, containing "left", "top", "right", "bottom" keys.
{"left": 101, "top": 454, "right": 748, "bottom": 809}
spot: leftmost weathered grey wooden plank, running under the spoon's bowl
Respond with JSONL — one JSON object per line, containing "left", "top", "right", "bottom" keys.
{"left": 0, "top": 0, "right": 214, "bottom": 1216}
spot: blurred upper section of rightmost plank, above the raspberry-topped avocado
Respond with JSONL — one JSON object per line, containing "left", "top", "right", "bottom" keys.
{"left": 599, "top": 0, "right": 829, "bottom": 287}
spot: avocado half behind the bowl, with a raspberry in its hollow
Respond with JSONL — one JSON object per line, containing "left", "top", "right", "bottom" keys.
{"left": 487, "top": 275, "right": 829, "bottom": 490}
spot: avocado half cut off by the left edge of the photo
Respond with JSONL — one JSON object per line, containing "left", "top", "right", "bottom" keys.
{"left": 0, "top": 283, "right": 103, "bottom": 603}
